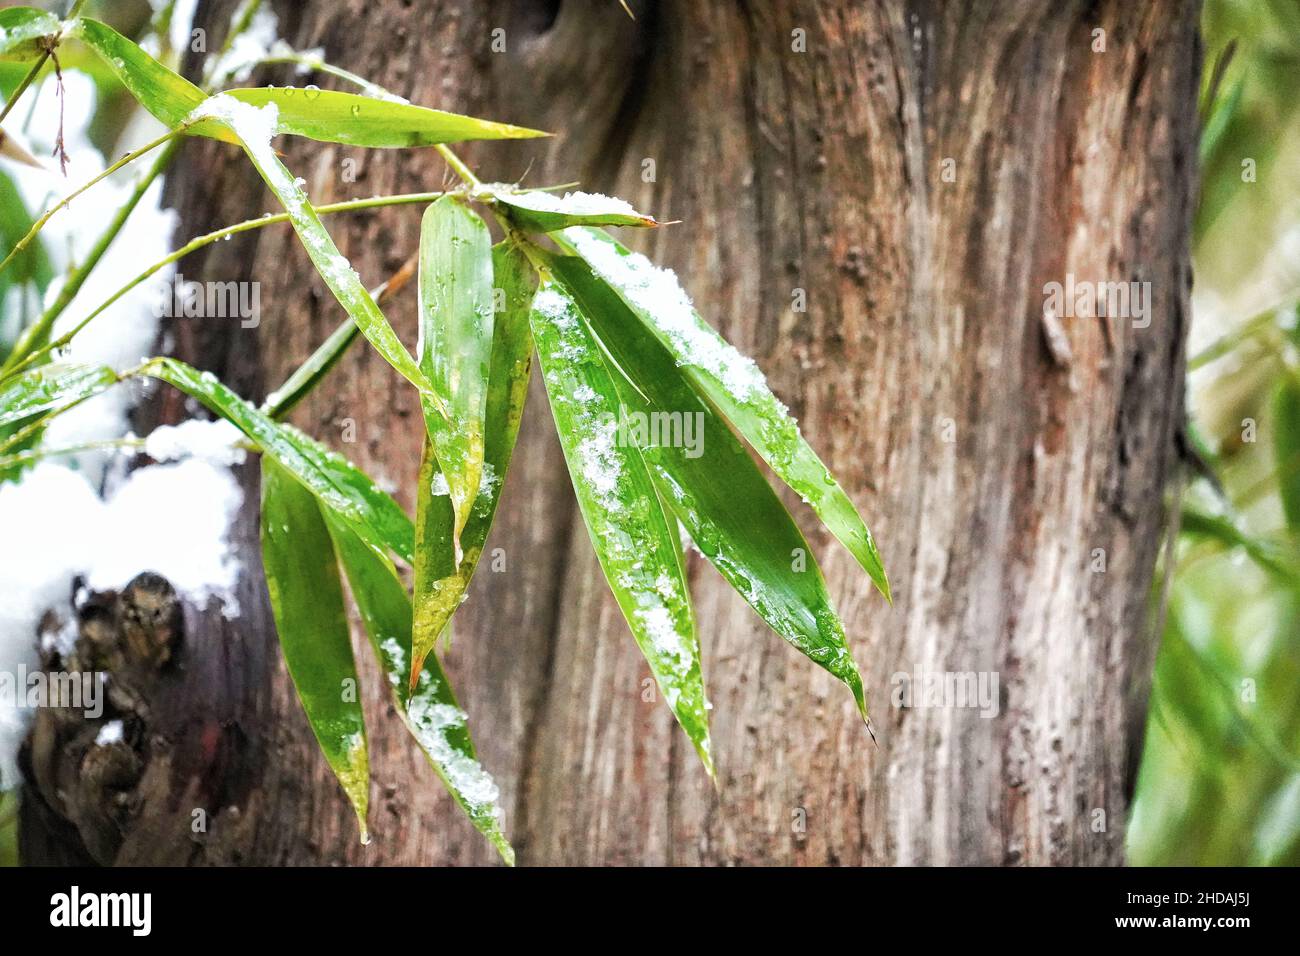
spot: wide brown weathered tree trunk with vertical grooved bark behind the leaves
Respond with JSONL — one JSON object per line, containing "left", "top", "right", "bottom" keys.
{"left": 25, "top": 0, "right": 1200, "bottom": 865}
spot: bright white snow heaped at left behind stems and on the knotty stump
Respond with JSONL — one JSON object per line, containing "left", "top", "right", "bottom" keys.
{"left": 0, "top": 63, "right": 242, "bottom": 790}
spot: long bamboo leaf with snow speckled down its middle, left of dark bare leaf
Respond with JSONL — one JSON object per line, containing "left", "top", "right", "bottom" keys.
{"left": 529, "top": 277, "right": 714, "bottom": 777}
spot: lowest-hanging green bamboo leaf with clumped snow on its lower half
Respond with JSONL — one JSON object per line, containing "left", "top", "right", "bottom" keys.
{"left": 325, "top": 512, "right": 515, "bottom": 865}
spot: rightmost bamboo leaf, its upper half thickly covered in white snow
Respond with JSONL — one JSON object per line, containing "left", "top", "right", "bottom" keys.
{"left": 558, "top": 229, "right": 892, "bottom": 601}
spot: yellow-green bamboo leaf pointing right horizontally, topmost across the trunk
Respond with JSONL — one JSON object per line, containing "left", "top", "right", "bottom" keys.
{"left": 225, "top": 86, "right": 547, "bottom": 148}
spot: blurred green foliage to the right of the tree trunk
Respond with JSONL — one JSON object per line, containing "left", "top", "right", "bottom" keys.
{"left": 1127, "top": 0, "right": 1300, "bottom": 865}
